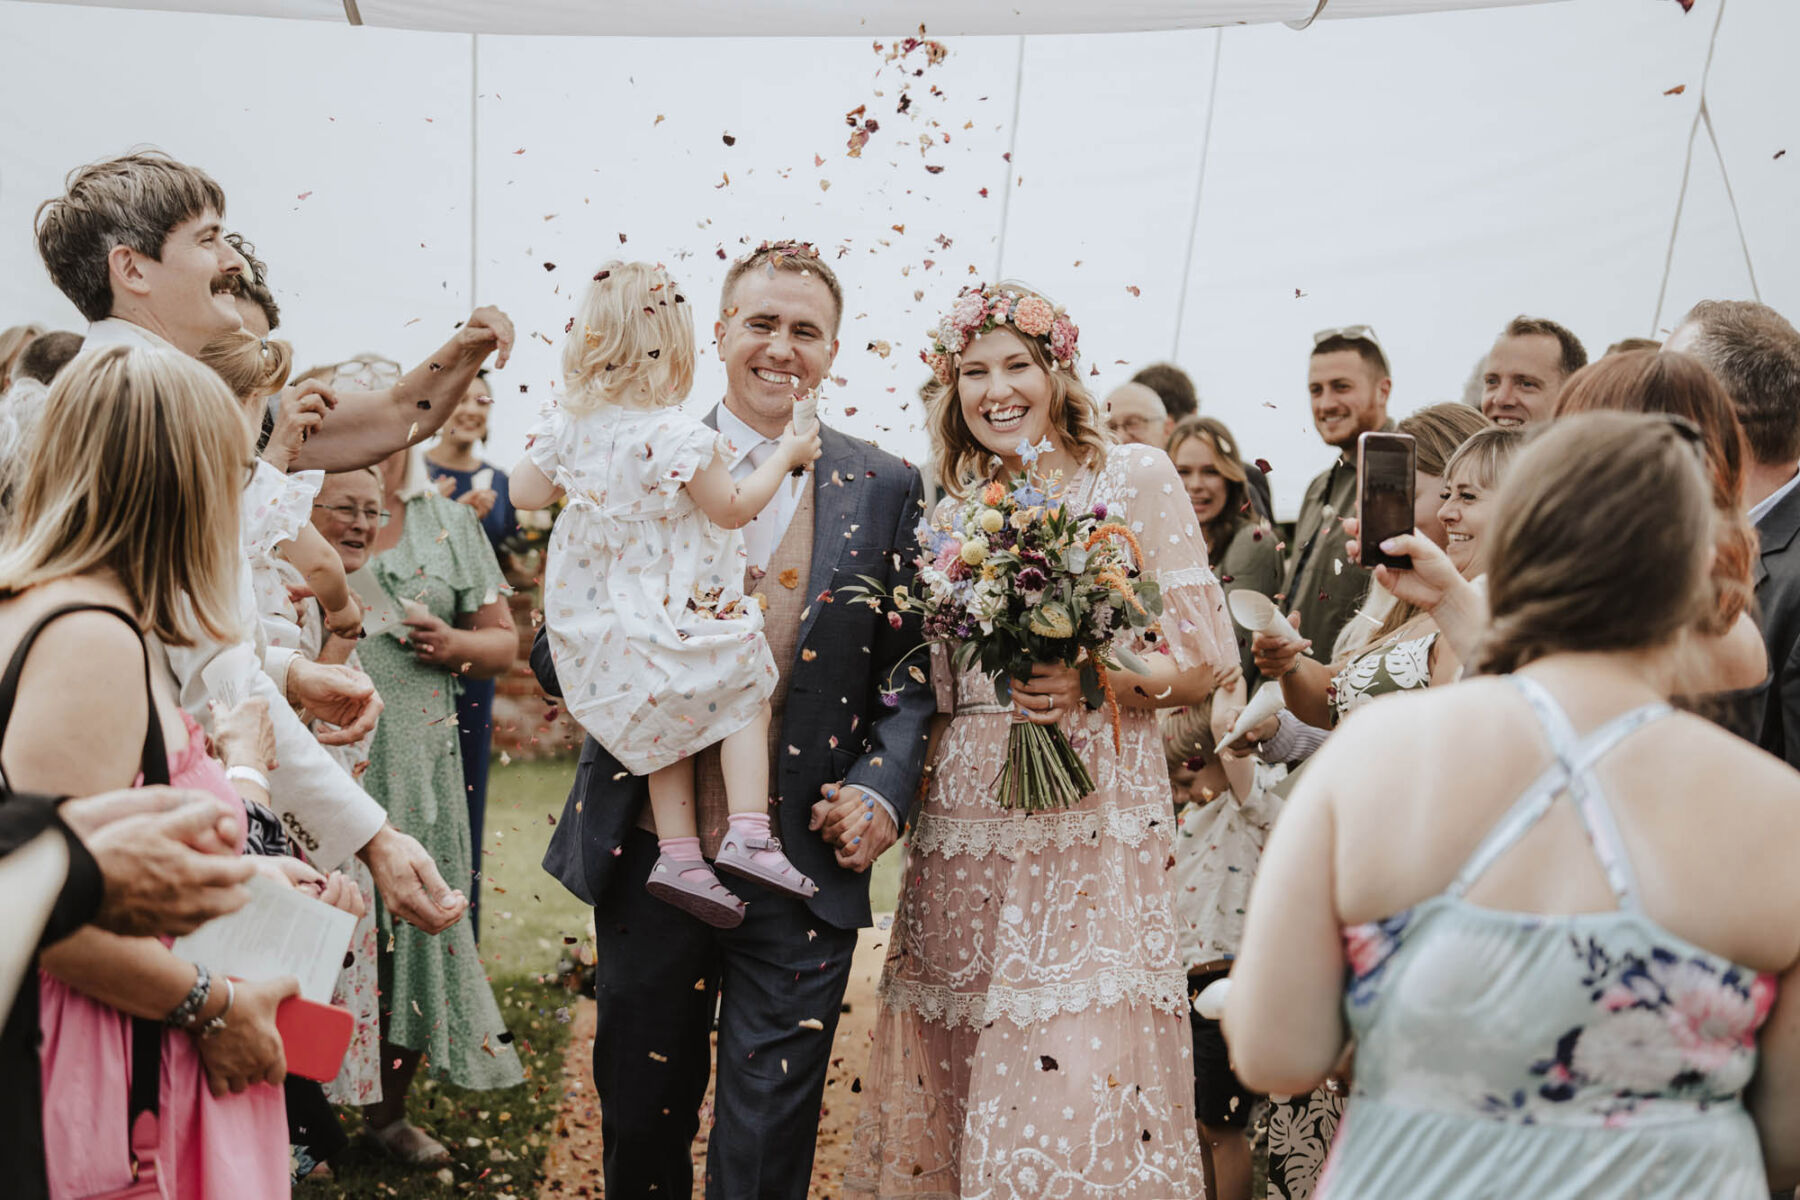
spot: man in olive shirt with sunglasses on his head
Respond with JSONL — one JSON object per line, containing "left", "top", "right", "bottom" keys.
{"left": 1282, "top": 326, "right": 1393, "bottom": 662}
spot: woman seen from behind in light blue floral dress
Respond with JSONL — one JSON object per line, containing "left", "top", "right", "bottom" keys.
{"left": 1226, "top": 414, "right": 1800, "bottom": 1200}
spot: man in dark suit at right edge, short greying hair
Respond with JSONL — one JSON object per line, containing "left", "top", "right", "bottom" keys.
{"left": 1667, "top": 300, "right": 1800, "bottom": 766}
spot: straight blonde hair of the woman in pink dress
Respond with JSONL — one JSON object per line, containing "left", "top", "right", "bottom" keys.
{"left": 0, "top": 345, "right": 252, "bottom": 646}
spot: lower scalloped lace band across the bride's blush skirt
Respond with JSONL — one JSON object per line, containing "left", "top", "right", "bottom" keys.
{"left": 880, "top": 966, "right": 1188, "bottom": 1029}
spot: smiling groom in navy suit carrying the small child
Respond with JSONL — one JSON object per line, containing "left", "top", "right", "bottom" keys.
{"left": 531, "top": 243, "right": 936, "bottom": 1200}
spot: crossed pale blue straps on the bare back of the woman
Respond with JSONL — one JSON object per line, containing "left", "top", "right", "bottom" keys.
{"left": 1445, "top": 675, "right": 1672, "bottom": 909}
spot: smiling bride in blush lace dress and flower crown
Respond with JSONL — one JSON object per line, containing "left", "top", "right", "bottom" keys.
{"left": 846, "top": 284, "right": 1238, "bottom": 1200}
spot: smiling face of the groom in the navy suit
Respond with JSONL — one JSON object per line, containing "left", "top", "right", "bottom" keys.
{"left": 713, "top": 268, "right": 837, "bottom": 435}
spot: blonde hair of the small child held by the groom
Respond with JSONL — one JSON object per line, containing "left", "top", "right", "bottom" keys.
{"left": 562, "top": 261, "right": 695, "bottom": 416}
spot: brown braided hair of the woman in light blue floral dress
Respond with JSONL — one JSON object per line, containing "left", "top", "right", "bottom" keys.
{"left": 1472, "top": 412, "right": 1721, "bottom": 675}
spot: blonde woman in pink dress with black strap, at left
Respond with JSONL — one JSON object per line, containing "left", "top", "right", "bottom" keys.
{"left": 0, "top": 347, "right": 295, "bottom": 1200}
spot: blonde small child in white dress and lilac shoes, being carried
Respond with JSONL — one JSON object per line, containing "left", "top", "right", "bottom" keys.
{"left": 511, "top": 263, "right": 819, "bottom": 928}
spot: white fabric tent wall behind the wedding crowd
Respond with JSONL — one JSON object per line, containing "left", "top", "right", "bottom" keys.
{"left": 0, "top": 0, "right": 1800, "bottom": 513}
